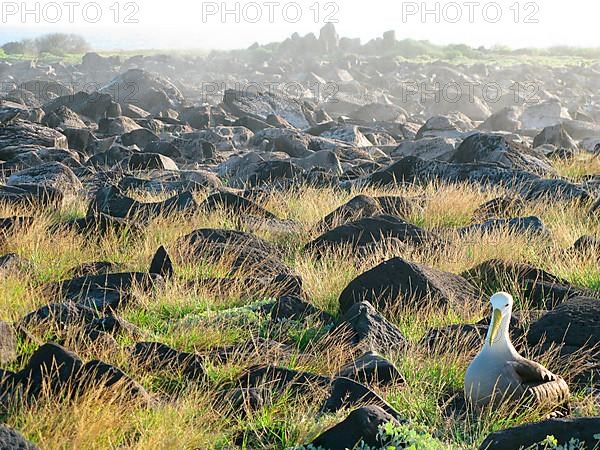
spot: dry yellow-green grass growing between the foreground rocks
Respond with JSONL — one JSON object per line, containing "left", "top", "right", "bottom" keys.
{"left": 0, "top": 171, "right": 600, "bottom": 450}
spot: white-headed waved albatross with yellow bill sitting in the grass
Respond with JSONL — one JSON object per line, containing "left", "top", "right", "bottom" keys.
{"left": 465, "top": 292, "right": 569, "bottom": 409}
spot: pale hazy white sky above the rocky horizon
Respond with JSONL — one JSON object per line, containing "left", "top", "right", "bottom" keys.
{"left": 0, "top": 0, "right": 600, "bottom": 49}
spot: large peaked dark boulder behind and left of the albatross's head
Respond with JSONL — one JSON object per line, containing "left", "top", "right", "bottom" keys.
{"left": 339, "top": 258, "right": 479, "bottom": 313}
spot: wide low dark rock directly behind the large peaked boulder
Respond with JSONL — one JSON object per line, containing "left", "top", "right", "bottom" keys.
{"left": 306, "top": 216, "right": 437, "bottom": 252}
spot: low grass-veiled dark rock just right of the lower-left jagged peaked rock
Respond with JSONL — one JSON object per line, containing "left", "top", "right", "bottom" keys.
{"left": 131, "top": 342, "right": 205, "bottom": 381}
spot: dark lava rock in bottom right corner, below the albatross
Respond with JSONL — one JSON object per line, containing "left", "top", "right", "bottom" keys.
{"left": 479, "top": 417, "right": 600, "bottom": 450}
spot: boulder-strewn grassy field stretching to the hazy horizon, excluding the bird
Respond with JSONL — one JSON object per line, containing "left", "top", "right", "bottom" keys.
{"left": 0, "top": 26, "right": 600, "bottom": 450}
